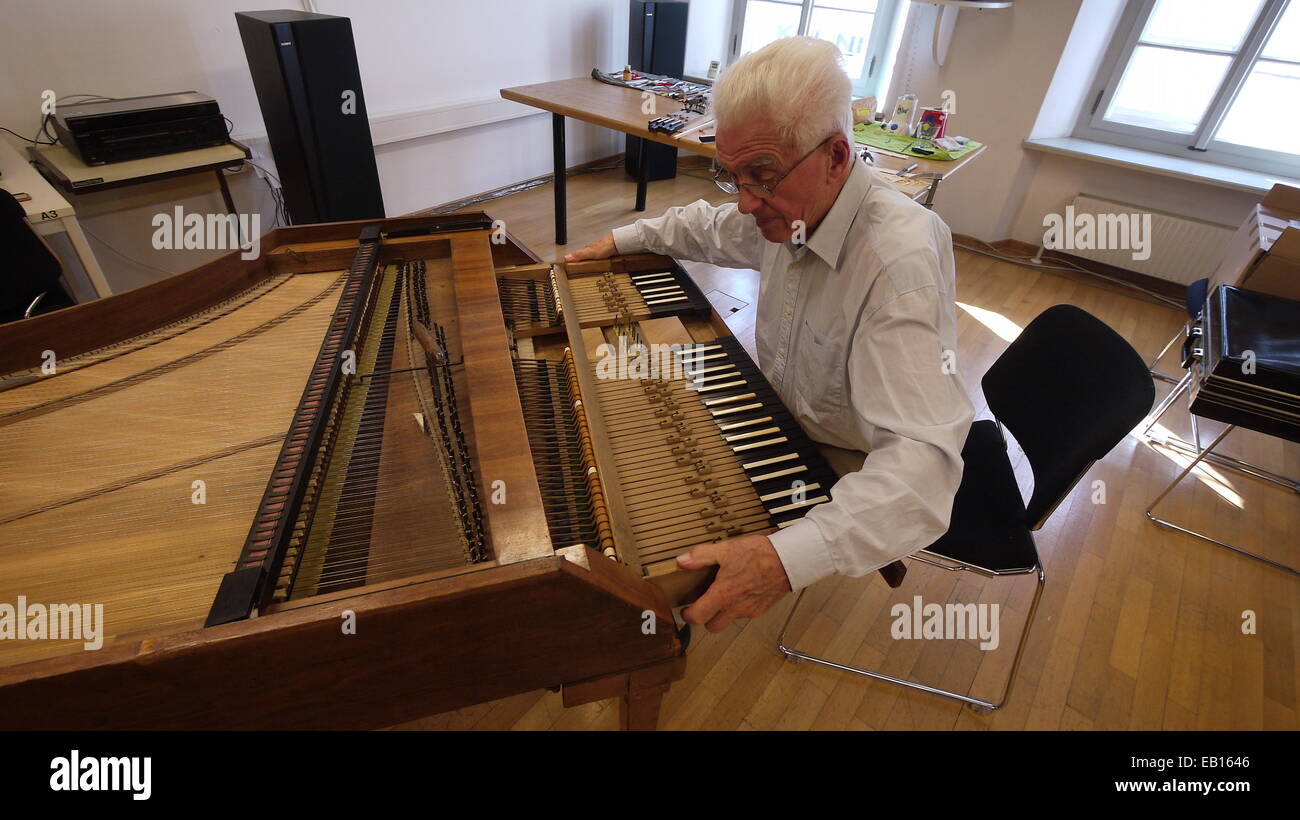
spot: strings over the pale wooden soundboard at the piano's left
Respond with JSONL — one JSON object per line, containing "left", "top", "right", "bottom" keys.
{"left": 0, "top": 272, "right": 342, "bottom": 663}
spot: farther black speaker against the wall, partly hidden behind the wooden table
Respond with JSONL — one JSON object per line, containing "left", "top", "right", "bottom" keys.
{"left": 627, "top": 0, "right": 690, "bottom": 182}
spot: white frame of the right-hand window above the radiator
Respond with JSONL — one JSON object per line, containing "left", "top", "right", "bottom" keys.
{"left": 1074, "top": 0, "right": 1300, "bottom": 177}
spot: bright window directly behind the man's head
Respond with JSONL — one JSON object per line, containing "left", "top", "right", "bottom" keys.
{"left": 731, "top": 0, "right": 906, "bottom": 96}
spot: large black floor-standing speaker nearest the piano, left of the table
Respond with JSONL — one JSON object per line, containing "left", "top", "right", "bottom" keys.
{"left": 235, "top": 10, "right": 385, "bottom": 225}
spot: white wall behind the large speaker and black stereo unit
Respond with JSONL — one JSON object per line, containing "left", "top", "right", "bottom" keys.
{"left": 0, "top": 0, "right": 634, "bottom": 293}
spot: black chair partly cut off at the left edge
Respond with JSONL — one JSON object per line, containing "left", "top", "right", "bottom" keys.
{"left": 0, "top": 188, "right": 72, "bottom": 324}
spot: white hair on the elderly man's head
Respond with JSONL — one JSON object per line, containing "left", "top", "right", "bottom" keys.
{"left": 712, "top": 36, "right": 853, "bottom": 152}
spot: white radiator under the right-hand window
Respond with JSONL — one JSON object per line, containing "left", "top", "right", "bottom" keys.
{"left": 1043, "top": 194, "right": 1236, "bottom": 285}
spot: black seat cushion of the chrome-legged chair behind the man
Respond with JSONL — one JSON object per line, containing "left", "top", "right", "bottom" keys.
{"left": 927, "top": 420, "right": 1039, "bottom": 572}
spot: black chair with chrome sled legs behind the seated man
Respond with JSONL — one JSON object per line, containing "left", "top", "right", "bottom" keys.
{"left": 777, "top": 304, "right": 1156, "bottom": 712}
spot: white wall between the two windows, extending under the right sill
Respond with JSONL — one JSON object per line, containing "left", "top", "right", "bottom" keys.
{"left": 888, "top": 0, "right": 1258, "bottom": 253}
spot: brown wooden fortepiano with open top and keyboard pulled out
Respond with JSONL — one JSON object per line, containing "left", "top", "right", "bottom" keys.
{"left": 0, "top": 213, "right": 835, "bottom": 729}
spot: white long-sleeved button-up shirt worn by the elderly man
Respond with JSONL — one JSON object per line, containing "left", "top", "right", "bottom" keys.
{"left": 614, "top": 162, "right": 974, "bottom": 590}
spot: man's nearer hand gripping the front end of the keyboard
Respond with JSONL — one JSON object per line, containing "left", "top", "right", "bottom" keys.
{"left": 677, "top": 535, "right": 790, "bottom": 633}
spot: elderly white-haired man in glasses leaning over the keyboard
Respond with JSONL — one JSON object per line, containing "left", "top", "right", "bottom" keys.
{"left": 567, "top": 38, "right": 972, "bottom": 632}
